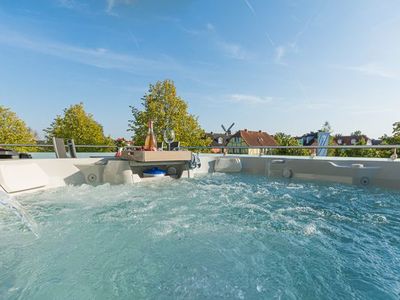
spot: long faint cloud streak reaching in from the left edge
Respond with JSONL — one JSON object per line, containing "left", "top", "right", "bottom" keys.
{"left": 0, "top": 28, "right": 180, "bottom": 73}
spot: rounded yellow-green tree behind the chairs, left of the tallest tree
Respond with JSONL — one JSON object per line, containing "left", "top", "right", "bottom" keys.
{"left": 44, "top": 103, "right": 114, "bottom": 152}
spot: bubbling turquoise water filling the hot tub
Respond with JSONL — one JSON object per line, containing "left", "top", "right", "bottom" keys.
{"left": 0, "top": 174, "right": 400, "bottom": 299}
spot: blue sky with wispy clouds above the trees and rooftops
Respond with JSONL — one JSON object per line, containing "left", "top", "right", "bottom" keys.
{"left": 0, "top": 0, "right": 400, "bottom": 137}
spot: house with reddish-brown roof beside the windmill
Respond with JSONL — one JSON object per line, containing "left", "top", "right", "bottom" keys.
{"left": 227, "top": 129, "right": 277, "bottom": 155}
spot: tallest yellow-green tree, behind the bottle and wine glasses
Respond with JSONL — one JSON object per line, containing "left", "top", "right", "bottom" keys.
{"left": 128, "top": 80, "right": 211, "bottom": 146}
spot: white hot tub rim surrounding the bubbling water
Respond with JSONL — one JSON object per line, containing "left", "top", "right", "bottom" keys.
{"left": 0, "top": 154, "right": 400, "bottom": 196}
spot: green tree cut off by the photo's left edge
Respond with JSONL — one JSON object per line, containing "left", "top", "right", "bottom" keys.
{"left": 0, "top": 105, "right": 36, "bottom": 152}
